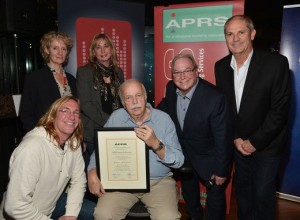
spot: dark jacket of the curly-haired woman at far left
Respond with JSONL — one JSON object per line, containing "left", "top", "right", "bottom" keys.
{"left": 20, "top": 65, "right": 77, "bottom": 131}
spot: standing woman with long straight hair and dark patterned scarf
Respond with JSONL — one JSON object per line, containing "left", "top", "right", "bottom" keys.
{"left": 76, "top": 33, "right": 124, "bottom": 159}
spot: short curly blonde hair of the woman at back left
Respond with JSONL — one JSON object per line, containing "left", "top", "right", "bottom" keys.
{"left": 40, "top": 31, "right": 73, "bottom": 65}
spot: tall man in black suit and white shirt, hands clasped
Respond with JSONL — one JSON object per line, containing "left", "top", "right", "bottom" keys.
{"left": 215, "top": 15, "right": 291, "bottom": 220}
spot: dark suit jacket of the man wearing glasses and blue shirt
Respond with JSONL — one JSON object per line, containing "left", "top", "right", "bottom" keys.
{"left": 157, "top": 78, "right": 233, "bottom": 180}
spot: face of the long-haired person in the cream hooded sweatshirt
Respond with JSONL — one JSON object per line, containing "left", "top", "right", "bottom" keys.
{"left": 53, "top": 99, "right": 80, "bottom": 142}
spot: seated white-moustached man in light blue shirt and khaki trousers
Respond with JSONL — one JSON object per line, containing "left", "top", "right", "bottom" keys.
{"left": 88, "top": 80, "right": 184, "bottom": 220}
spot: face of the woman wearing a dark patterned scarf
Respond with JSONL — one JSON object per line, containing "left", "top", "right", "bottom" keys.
{"left": 94, "top": 38, "right": 112, "bottom": 66}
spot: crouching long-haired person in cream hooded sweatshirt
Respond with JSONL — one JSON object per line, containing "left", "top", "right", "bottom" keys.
{"left": 0, "top": 96, "right": 93, "bottom": 220}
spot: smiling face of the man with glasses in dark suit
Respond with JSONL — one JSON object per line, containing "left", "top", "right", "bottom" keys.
{"left": 172, "top": 57, "right": 198, "bottom": 95}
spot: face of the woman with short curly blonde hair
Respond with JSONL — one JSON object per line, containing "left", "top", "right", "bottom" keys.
{"left": 45, "top": 39, "right": 68, "bottom": 66}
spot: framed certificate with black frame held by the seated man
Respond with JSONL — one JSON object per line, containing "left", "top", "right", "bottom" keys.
{"left": 95, "top": 127, "right": 150, "bottom": 192}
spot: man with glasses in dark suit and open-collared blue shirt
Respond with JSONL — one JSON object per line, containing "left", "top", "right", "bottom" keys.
{"left": 158, "top": 54, "right": 233, "bottom": 220}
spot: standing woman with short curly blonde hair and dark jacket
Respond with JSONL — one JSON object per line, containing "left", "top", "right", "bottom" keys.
{"left": 20, "top": 31, "right": 77, "bottom": 132}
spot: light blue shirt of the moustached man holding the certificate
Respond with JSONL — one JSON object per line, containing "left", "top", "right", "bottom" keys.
{"left": 88, "top": 103, "right": 184, "bottom": 179}
